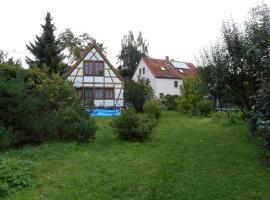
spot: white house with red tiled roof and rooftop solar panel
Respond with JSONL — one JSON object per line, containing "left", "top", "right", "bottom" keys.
{"left": 132, "top": 56, "right": 196, "bottom": 97}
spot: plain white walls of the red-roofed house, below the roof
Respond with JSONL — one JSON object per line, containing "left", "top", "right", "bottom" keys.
{"left": 132, "top": 60, "right": 183, "bottom": 97}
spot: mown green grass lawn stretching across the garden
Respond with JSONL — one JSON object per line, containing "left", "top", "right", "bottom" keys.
{"left": 0, "top": 112, "right": 270, "bottom": 200}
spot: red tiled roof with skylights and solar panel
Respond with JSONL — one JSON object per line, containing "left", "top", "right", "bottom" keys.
{"left": 143, "top": 57, "right": 196, "bottom": 79}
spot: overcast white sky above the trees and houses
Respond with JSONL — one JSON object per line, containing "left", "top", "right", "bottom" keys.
{"left": 0, "top": 0, "right": 270, "bottom": 67}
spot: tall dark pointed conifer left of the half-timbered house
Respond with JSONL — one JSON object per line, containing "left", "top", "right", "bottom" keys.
{"left": 26, "top": 12, "right": 62, "bottom": 73}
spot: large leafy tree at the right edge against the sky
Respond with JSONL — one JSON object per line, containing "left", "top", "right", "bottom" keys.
{"left": 199, "top": 4, "right": 270, "bottom": 117}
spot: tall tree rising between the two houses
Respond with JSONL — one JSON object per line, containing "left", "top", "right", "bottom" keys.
{"left": 117, "top": 31, "right": 148, "bottom": 79}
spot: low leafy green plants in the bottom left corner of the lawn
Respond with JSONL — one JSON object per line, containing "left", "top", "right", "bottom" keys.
{"left": 0, "top": 160, "right": 36, "bottom": 199}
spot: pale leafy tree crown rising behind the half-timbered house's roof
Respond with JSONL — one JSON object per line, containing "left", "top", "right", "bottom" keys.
{"left": 59, "top": 28, "right": 106, "bottom": 64}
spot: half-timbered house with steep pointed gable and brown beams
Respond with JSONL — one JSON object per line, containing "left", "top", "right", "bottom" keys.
{"left": 66, "top": 43, "right": 124, "bottom": 107}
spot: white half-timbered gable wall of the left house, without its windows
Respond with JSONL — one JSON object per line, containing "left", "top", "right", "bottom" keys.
{"left": 67, "top": 48, "right": 124, "bottom": 107}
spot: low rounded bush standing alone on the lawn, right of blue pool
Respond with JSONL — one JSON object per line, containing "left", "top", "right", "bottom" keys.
{"left": 112, "top": 109, "right": 156, "bottom": 141}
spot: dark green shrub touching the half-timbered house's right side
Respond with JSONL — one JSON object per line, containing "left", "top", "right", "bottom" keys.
{"left": 124, "top": 80, "right": 154, "bottom": 112}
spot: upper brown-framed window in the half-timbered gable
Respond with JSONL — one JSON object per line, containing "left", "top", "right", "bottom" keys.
{"left": 83, "top": 61, "right": 104, "bottom": 76}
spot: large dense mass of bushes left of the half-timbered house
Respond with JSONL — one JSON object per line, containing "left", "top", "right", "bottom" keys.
{"left": 0, "top": 65, "right": 96, "bottom": 148}
